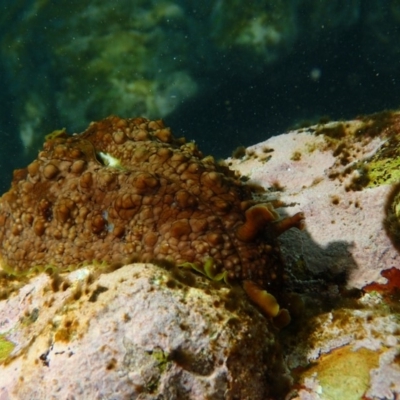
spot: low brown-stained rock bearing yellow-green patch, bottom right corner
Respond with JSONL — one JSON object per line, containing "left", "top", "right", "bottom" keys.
{"left": 282, "top": 293, "right": 400, "bottom": 400}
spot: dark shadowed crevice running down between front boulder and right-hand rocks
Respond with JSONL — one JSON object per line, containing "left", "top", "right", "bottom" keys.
{"left": 278, "top": 229, "right": 362, "bottom": 396}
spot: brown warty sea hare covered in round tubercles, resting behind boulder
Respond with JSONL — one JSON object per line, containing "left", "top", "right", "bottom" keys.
{"left": 0, "top": 116, "right": 303, "bottom": 314}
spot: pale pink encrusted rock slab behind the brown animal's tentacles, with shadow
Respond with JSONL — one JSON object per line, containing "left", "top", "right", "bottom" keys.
{"left": 228, "top": 120, "right": 400, "bottom": 289}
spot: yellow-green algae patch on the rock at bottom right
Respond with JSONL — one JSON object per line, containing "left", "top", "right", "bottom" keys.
{"left": 305, "top": 346, "right": 379, "bottom": 400}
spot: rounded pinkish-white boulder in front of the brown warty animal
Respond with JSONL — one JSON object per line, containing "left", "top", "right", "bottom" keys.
{"left": 0, "top": 264, "right": 285, "bottom": 400}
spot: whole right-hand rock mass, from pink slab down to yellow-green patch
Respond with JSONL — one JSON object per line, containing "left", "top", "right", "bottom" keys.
{"left": 228, "top": 112, "right": 400, "bottom": 400}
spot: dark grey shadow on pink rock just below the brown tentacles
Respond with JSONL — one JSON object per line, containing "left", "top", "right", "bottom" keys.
{"left": 279, "top": 225, "right": 362, "bottom": 323}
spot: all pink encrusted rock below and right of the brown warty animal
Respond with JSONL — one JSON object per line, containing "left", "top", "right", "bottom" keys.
{"left": 0, "top": 113, "right": 400, "bottom": 400}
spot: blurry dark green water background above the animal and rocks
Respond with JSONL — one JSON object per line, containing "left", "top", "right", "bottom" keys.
{"left": 0, "top": 0, "right": 400, "bottom": 193}
